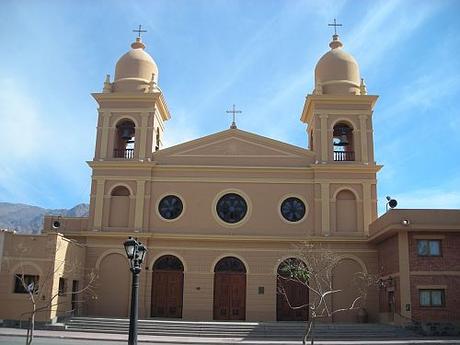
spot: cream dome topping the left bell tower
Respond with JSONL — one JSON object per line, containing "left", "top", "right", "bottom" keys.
{"left": 113, "top": 37, "right": 158, "bottom": 92}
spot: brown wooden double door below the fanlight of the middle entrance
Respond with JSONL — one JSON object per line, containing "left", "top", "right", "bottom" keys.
{"left": 214, "top": 272, "right": 246, "bottom": 320}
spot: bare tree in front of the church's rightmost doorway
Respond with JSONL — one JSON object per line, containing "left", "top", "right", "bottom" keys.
{"left": 277, "top": 242, "right": 375, "bottom": 345}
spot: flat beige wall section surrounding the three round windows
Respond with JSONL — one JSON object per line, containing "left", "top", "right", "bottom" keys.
{"left": 149, "top": 182, "right": 314, "bottom": 236}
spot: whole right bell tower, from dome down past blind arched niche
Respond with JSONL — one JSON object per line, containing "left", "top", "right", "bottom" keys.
{"left": 301, "top": 33, "right": 380, "bottom": 236}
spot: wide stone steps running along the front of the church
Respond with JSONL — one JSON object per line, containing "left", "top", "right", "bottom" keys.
{"left": 65, "top": 317, "right": 414, "bottom": 339}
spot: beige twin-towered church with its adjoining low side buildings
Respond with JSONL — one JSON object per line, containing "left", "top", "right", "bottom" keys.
{"left": 0, "top": 30, "right": 460, "bottom": 322}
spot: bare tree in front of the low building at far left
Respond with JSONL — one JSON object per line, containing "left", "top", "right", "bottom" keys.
{"left": 7, "top": 236, "right": 97, "bottom": 345}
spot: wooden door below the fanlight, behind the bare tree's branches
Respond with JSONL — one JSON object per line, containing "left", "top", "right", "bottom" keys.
{"left": 276, "top": 277, "right": 308, "bottom": 321}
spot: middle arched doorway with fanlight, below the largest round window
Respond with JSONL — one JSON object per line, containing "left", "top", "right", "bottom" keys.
{"left": 214, "top": 256, "right": 246, "bottom": 320}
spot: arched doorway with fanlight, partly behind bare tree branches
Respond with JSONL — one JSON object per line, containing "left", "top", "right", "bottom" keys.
{"left": 276, "top": 258, "right": 309, "bottom": 321}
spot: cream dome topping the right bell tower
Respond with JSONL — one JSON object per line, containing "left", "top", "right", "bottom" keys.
{"left": 315, "top": 35, "right": 361, "bottom": 95}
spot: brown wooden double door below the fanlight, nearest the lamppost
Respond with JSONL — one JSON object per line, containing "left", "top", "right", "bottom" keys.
{"left": 151, "top": 271, "right": 184, "bottom": 318}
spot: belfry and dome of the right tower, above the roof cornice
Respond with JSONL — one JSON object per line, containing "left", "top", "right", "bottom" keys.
{"left": 301, "top": 34, "right": 378, "bottom": 165}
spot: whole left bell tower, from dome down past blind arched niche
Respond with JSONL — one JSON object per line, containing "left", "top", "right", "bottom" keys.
{"left": 88, "top": 37, "right": 170, "bottom": 231}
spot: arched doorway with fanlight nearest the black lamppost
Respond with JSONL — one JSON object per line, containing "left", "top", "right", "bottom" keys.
{"left": 151, "top": 255, "right": 184, "bottom": 318}
